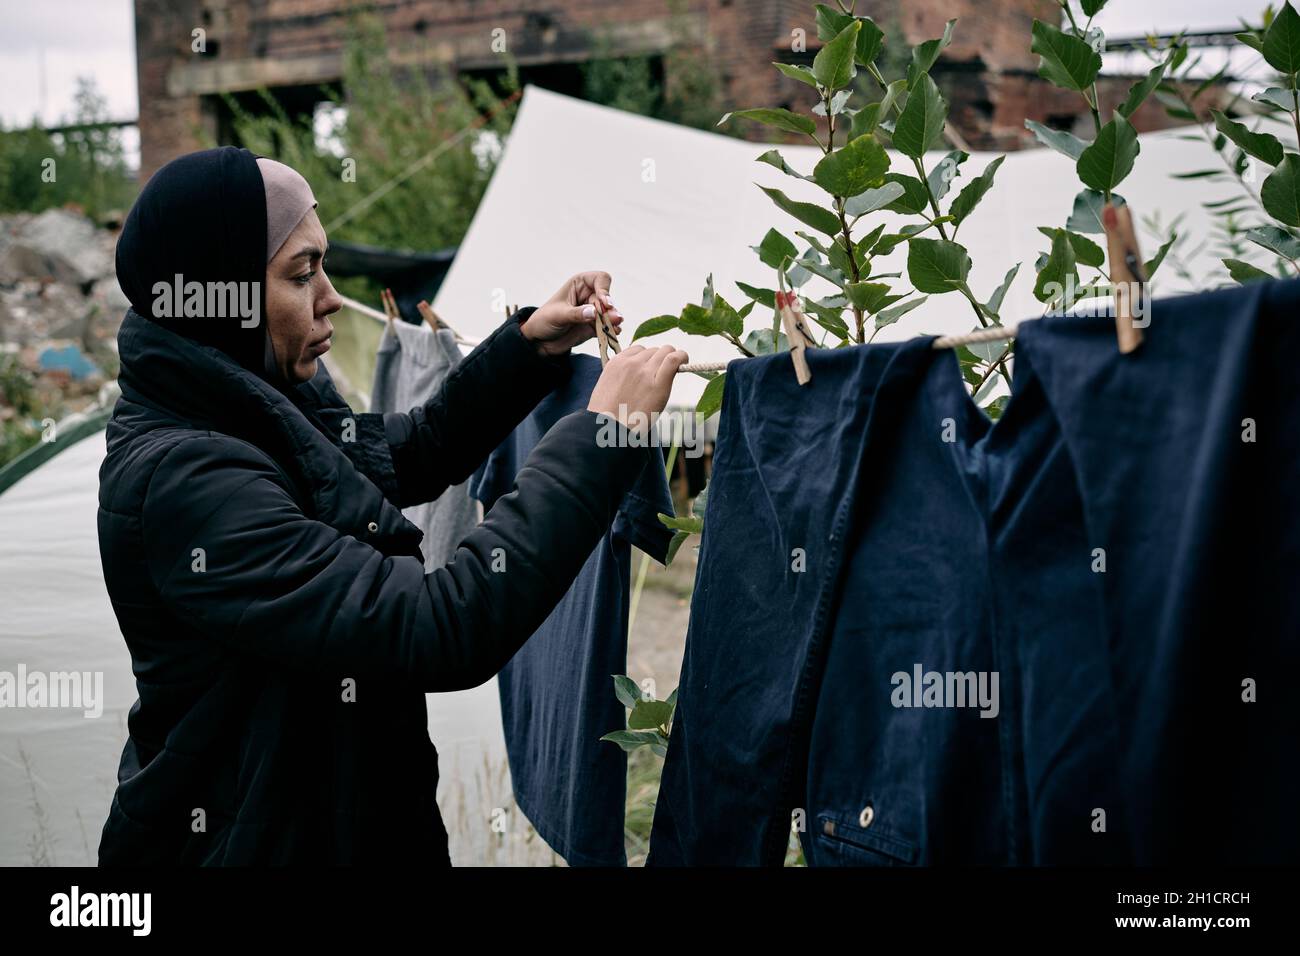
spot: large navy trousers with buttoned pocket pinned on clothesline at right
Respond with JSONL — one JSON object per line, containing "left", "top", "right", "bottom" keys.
{"left": 649, "top": 282, "right": 1300, "bottom": 865}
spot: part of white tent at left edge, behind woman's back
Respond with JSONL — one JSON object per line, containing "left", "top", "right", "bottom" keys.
{"left": 0, "top": 427, "right": 135, "bottom": 866}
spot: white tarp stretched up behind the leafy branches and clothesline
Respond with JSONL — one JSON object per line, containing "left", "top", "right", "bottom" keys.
{"left": 434, "top": 86, "right": 1232, "bottom": 405}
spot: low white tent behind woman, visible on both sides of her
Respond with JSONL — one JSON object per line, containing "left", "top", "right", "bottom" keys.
{"left": 0, "top": 432, "right": 559, "bottom": 866}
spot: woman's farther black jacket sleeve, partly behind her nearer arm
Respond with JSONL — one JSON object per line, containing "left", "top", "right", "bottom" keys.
{"left": 361, "top": 307, "right": 571, "bottom": 507}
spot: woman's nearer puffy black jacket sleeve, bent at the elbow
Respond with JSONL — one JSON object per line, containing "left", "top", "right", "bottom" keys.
{"left": 142, "top": 411, "right": 650, "bottom": 691}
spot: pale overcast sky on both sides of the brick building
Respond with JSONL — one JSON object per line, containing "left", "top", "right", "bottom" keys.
{"left": 0, "top": 0, "right": 1279, "bottom": 126}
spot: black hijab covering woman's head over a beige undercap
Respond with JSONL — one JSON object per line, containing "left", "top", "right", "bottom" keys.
{"left": 117, "top": 146, "right": 278, "bottom": 385}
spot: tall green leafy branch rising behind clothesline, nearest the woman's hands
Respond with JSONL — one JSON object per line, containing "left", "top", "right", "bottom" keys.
{"left": 633, "top": 0, "right": 1015, "bottom": 415}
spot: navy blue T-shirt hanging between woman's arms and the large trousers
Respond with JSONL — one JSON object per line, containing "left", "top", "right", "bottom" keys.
{"left": 469, "top": 355, "right": 673, "bottom": 866}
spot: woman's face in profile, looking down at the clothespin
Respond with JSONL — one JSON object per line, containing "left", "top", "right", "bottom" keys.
{"left": 267, "top": 209, "right": 343, "bottom": 384}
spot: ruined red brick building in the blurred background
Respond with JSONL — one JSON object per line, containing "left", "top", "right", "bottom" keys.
{"left": 135, "top": 0, "right": 1185, "bottom": 177}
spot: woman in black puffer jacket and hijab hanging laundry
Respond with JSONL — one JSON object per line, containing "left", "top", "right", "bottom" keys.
{"left": 99, "top": 147, "right": 686, "bottom": 865}
